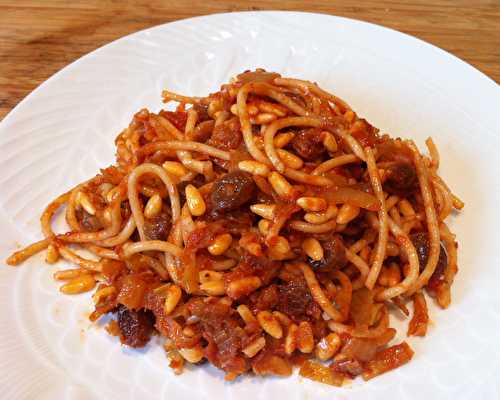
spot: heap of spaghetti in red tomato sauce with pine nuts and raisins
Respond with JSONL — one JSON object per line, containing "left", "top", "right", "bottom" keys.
{"left": 7, "top": 69, "right": 463, "bottom": 385}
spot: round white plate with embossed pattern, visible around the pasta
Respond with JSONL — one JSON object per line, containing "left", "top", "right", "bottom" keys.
{"left": 0, "top": 12, "right": 500, "bottom": 399}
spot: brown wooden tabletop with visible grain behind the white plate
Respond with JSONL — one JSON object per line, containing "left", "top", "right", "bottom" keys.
{"left": 0, "top": 0, "right": 500, "bottom": 120}
